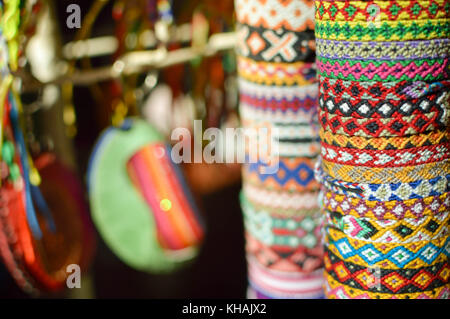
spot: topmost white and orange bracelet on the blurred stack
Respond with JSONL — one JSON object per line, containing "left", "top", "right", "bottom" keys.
{"left": 235, "top": 0, "right": 315, "bottom": 32}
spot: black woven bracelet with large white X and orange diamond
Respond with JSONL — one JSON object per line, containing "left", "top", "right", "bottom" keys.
{"left": 237, "top": 24, "right": 315, "bottom": 62}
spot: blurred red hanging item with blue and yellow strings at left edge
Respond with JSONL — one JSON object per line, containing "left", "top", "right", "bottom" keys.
{"left": 0, "top": 1, "right": 94, "bottom": 294}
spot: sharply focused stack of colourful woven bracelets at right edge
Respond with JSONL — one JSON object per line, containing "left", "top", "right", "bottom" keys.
{"left": 315, "top": 0, "right": 450, "bottom": 299}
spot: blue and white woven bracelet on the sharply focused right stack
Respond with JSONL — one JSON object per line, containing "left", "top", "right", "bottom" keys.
{"left": 316, "top": 169, "right": 450, "bottom": 201}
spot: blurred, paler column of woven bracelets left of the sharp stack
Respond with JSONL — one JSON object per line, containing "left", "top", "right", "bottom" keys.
{"left": 236, "top": 0, "right": 323, "bottom": 298}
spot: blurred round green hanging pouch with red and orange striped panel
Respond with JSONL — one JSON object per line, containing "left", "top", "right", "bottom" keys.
{"left": 88, "top": 1, "right": 205, "bottom": 273}
